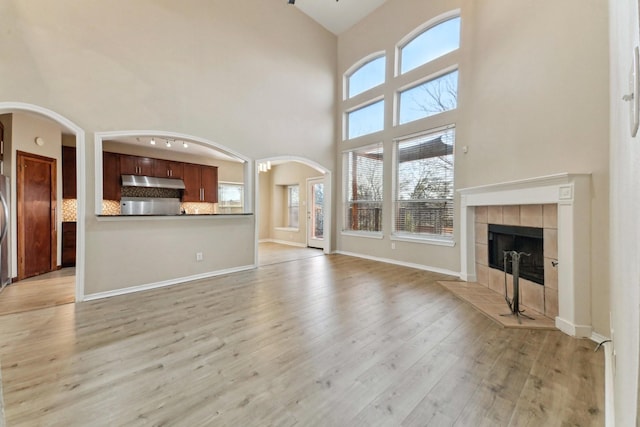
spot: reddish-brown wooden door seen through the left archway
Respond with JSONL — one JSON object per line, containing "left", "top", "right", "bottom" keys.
{"left": 16, "top": 151, "right": 58, "bottom": 280}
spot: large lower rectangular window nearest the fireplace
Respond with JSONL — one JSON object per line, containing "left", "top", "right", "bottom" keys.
{"left": 394, "top": 128, "right": 455, "bottom": 239}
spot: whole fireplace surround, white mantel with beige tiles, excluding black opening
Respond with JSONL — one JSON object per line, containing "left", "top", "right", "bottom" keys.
{"left": 458, "top": 173, "right": 592, "bottom": 337}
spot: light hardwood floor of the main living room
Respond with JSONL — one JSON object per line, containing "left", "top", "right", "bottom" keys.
{"left": 0, "top": 255, "right": 604, "bottom": 427}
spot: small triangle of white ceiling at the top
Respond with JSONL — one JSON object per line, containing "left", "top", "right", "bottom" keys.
{"left": 292, "top": 0, "right": 385, "bottom": 35}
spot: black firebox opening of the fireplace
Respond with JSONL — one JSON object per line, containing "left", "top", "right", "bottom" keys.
{"left": 489, "top": 224, "right": 544, "bottom": 285}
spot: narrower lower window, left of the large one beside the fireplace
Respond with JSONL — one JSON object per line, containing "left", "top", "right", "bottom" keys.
{"left": 344, "top": 143, "right": 383, "bottom": 232}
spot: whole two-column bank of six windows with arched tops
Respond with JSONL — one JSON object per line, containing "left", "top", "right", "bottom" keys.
{"left": 340, "top": 10, "right": 462, "bottom": 242}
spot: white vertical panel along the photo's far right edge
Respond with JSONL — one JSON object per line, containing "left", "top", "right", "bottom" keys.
{"left": 609, "top": 0, "right": 640, "bottom": 426}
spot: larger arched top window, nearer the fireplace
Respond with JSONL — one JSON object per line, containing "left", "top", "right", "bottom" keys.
{"left": 400, "top": 16, "right": 460, "bottom": 74}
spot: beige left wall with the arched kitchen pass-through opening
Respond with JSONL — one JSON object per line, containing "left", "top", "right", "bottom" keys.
{"left": 0, "top": 0, "right": 336, "bottom": 294}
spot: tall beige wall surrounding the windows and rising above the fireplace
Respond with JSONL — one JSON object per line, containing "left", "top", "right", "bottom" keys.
{"left": 337, "top": 0, "right": 609, "bottom": 335}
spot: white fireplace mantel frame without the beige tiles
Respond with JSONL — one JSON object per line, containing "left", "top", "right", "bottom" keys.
{"left": 458, "top": 173, "right": 592, "bottom": 337}
